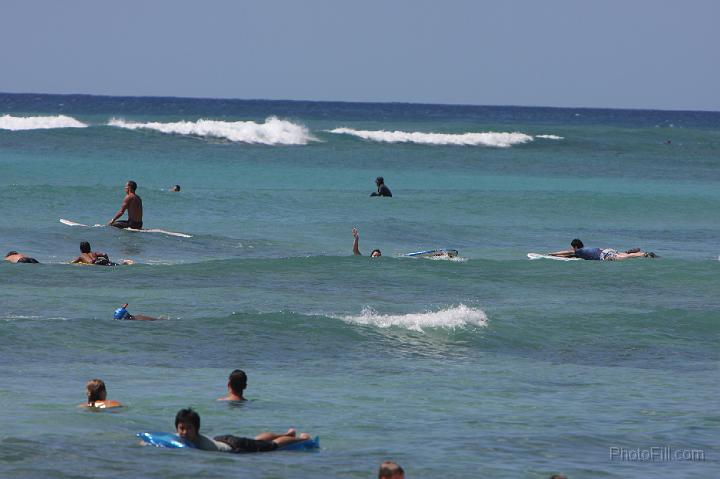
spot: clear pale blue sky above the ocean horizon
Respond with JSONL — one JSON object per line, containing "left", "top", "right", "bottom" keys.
{"left": 0, "top": 0, "right": 720, "bottom": 111}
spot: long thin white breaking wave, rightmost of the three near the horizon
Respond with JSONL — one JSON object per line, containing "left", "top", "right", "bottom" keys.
{"left": 329, "top": 128, "right": 533, "bottom": 148}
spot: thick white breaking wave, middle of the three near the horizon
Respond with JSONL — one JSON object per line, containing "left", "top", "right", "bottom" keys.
{"left": 108, "top": 117, "right": 316, "bottom": 145}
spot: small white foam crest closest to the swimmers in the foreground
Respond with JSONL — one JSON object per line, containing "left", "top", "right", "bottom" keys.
{"left": 340, "top": 304, "right": 488, "bottom": 331}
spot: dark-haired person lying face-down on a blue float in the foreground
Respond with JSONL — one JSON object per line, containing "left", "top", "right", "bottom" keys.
{"left": 175, "top": 408, "right": 310, "bottom": 453}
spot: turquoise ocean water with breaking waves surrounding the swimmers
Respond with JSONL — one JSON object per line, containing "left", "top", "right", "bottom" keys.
{"left": 0, "top": 95, "right": 720, "bottom": 478}
